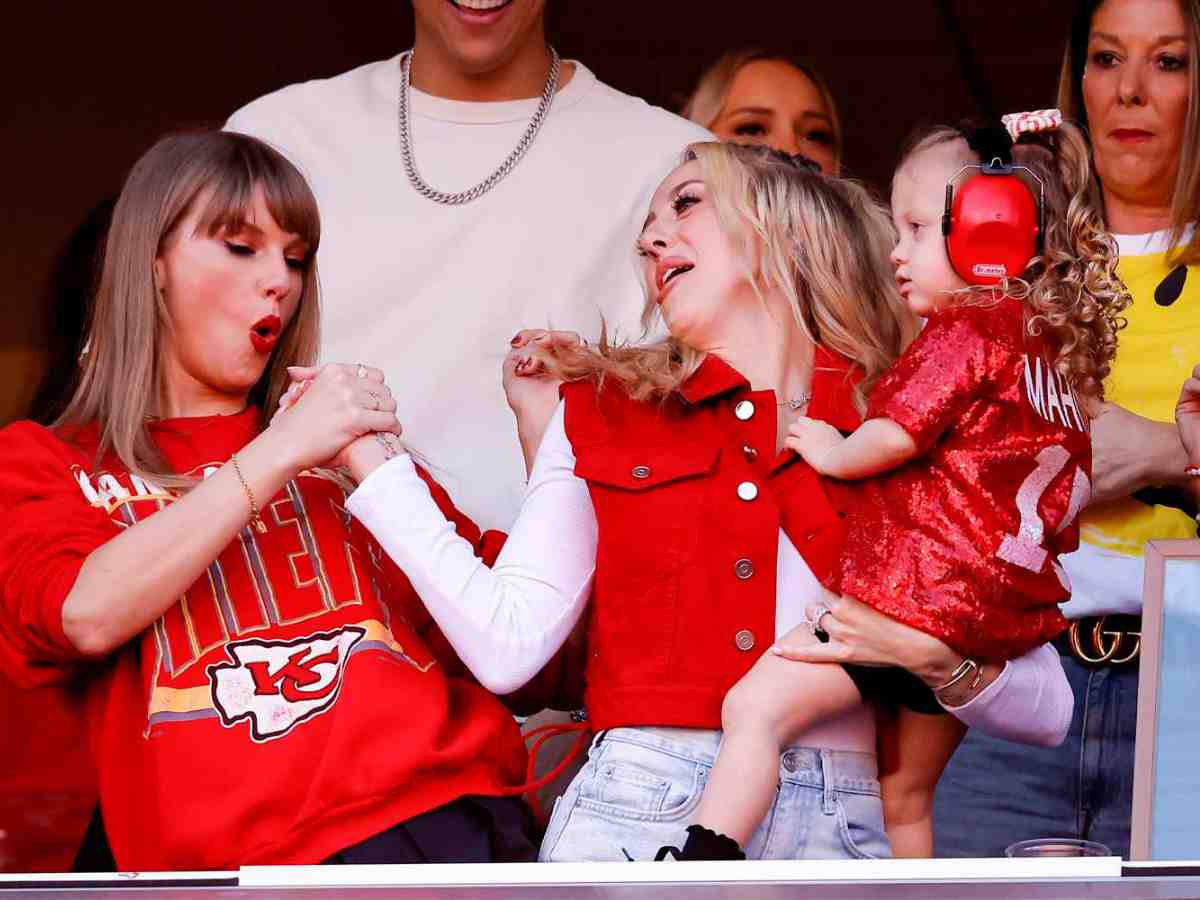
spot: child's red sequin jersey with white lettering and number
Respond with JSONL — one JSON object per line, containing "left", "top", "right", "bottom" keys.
{"left": 829, "top": 298, "right": 1092, "bottom": 660}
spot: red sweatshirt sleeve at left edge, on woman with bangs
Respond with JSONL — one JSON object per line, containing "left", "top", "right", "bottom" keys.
{"left": 0, "top": 422, "right": 119, "bottom": 688}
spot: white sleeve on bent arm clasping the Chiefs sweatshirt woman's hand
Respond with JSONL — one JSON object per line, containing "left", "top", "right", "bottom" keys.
{"left": 347, "top": 403, "right": 596, "bottom": 694}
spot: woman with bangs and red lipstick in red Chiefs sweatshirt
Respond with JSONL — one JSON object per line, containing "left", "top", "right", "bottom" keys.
{"left": 0, "top": 132, "right": 552, "bottom": 871}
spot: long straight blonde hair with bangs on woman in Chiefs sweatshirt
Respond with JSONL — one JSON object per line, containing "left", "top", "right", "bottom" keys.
{"left": 53, "top": 131, "right": 320, "bottom": 490}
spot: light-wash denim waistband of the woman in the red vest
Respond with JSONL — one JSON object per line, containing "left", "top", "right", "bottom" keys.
{"left": 593, "top": 726, "right": 878, "bottom": 790}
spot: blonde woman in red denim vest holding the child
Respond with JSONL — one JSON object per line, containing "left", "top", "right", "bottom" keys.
{"left": 347, "top": 144, "right": 1069, "bottom": 860}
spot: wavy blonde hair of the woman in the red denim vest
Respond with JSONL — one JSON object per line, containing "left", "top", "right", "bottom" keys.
{"left": 546, "top": 143, "right": 917, "bottom": 413}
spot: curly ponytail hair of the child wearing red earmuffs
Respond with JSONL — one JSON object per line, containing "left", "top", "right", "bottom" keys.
{"left": 896, "top": 122, "right": 1130, "bottom": 400}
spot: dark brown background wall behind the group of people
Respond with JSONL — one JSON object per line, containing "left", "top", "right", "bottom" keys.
{"left": 0, "top": 0, "right": 1070, "bottom": 424}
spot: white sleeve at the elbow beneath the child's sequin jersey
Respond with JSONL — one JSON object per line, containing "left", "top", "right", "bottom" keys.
{"left": 947, "top": 644, "right": 1075, "bottom": 746}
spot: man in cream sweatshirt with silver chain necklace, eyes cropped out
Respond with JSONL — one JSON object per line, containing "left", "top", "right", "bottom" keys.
{"left": 227, "top": 0, "right": 710, "bottom": 528}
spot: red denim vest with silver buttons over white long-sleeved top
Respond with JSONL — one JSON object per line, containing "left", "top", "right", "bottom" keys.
{"left": 563, "top": 347, "right": 862, "bottom": 730}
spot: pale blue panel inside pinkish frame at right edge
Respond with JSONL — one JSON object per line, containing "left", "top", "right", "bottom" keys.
{"left": 1150, "top": 559, "right": 1200, "bottom": 859}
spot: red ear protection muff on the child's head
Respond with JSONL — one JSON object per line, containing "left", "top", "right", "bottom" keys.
{"left": 942, "top": 156, "right": 1045, "bottom": 284}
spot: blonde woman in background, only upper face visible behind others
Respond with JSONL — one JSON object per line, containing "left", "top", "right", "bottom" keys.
{"left": 680, "top": 48, "right": 841, "bottom": 175}
